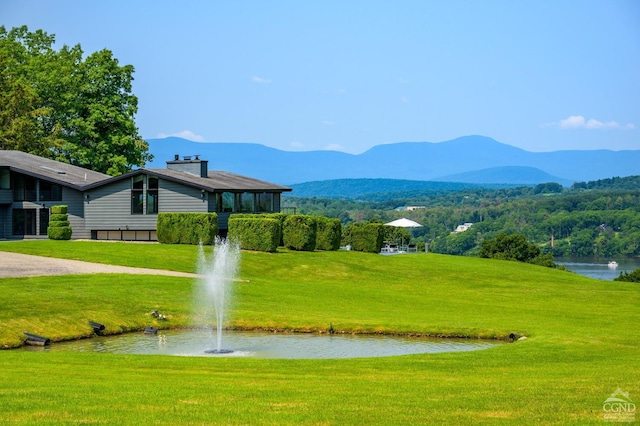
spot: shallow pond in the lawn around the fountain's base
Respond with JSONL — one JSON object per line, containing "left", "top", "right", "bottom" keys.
{"left": 24, "top": 330, "right": 505, "bottom": 359}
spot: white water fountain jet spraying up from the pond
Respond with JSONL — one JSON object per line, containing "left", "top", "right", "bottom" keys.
{"left": 195, "top": 237, "right": 240, "bottom": 354}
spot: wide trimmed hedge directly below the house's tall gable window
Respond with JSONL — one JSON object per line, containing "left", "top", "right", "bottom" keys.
{"left": 156, "top": 212, "right": 218, "bottom": 245}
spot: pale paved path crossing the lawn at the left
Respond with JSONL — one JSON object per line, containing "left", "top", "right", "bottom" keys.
{"left": 0, "top": 251, "right": 197, "bottom": 278}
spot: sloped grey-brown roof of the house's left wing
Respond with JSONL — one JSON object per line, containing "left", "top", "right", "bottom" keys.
{"left": 0, "top": 150, "right": 111, "bottom": 189}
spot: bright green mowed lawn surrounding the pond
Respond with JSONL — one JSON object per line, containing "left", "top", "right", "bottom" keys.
{"left": 0, "top": 241, "right": 640, "bottom": 424}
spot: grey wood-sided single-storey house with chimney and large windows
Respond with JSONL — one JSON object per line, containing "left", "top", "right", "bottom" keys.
{"left": 0, "top": 150, "right": 291, "bottom": 241}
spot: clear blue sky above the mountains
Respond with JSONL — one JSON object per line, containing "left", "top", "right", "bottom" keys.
{"left": 0, "top": 0, "right": 640, "bottom": 154}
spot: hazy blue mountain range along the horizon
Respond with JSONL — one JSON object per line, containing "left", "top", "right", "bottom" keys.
{"left": 146, "top": 136, "right": 640, "bottom": 186}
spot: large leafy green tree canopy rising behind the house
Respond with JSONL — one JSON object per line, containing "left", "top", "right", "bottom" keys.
{"left": 0, "top": 26, "right": 152, "bottom": 176}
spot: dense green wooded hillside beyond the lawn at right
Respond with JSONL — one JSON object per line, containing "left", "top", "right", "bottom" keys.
{"left": 284, "top": 176, "right": 640, "bottom": 256}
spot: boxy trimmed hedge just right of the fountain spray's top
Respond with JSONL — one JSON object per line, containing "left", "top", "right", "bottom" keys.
{"left": 227, "top": 215, "right": 282, "bottom": 253}
